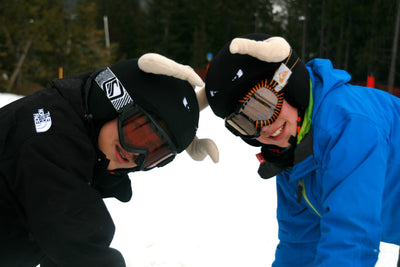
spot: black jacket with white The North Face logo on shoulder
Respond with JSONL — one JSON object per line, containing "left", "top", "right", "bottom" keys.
{"left": 0, "top": 73, "right": 131, "bottom": 266}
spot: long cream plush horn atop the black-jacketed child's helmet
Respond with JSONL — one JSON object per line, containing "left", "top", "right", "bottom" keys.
{"left": 138, "top": 53, "right": 204, "bottom": 88}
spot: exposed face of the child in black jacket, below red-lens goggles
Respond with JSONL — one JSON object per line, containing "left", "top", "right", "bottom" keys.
{"left": 98, "top": 118, "right": 138, "bottom": 170}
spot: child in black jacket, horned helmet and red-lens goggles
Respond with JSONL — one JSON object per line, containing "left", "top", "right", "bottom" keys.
{"left": 0, "top": 54, "right": 218, "bottom": 267}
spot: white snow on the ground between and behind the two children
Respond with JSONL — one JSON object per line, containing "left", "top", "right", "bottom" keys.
{"left": 0, "top": 94, "right": 398, "bottom": 267}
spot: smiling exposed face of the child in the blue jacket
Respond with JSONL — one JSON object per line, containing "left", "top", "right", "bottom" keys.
{"left": 257, "top": 100, "right": 298, "bottom": 147}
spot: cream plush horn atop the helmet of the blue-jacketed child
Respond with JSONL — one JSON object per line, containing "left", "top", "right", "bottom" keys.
{"left": 229, "top": 37, "right": 290, "bottom": 62}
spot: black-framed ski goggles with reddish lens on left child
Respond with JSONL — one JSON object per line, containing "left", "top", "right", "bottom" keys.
{"left": 118, "top": 105, "right": 177, "bottom": 171}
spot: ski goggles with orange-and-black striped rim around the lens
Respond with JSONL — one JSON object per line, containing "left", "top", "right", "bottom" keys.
{"left": 225, "top": 80, "right": 283, "bottom": 139}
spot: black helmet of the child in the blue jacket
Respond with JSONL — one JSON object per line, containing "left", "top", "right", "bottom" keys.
{"left": 206, "top": 33, "right": 310, "bottom": 118}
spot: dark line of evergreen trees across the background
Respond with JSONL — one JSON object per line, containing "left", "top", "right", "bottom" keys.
{"left": 0, "top": 0, "right": 400, "bottom": 94}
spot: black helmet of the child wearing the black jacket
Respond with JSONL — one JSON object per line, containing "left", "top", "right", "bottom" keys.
{"left": 87, "top": 59, "right": 199, "bottom": 153}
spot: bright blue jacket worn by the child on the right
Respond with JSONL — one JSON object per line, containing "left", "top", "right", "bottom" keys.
{"left": 273, "top": 59, "right": 400, "bottom": 267}
